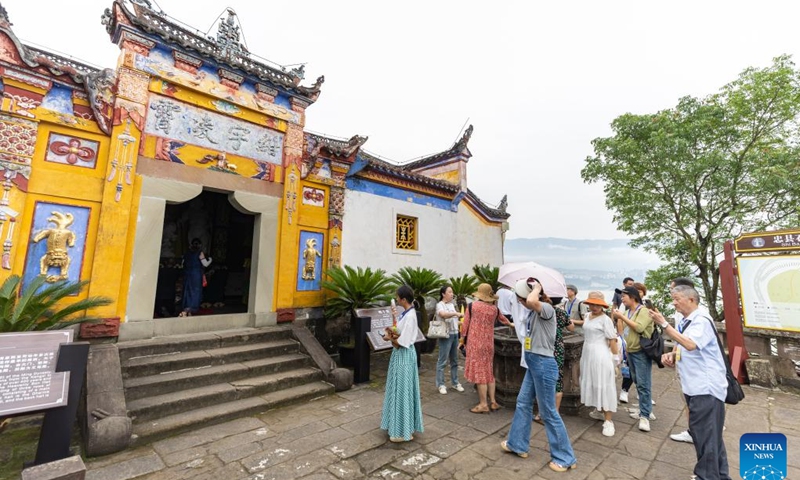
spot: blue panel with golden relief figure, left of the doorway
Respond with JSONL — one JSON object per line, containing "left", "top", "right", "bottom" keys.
{"left": 22, "top": 202, "right": 91, "bottom": 292}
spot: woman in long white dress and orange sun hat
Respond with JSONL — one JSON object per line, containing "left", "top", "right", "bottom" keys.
{"left": 581, "top": 292, "right": 619, "bottom": 437}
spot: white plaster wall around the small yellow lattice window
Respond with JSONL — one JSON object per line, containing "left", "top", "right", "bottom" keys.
{"left": 342, "top": 190, "right": 503, "bottom": 277}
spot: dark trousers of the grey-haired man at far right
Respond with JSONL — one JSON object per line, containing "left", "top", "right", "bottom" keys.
{"left": 684, "top": 395, "right": 731, "bottom": 480}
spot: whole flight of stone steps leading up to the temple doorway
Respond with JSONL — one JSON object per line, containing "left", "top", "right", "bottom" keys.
{"left": 117, "top": 327, "right": 334, "bottom": 445}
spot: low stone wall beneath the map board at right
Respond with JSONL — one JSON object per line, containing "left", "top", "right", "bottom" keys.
{"left": 717, "top": 323, "right": 800, "bottom": 388}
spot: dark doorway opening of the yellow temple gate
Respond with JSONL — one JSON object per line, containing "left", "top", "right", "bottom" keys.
{"left": 154, "top": 191, "right": 254, "bottom": 318}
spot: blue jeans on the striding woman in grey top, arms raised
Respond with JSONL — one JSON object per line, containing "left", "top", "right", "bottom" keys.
{"left": 508, "top": 352, "right": 577, "bottom": 467}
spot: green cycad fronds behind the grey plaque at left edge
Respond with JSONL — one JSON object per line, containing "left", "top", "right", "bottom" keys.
{"left": 0, "top": 275, "right": 111, "bottom": 333}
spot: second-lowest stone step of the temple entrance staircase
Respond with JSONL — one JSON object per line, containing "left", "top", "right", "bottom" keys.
{"left": 127, "top": 368, "right": 322, "bottom": 422}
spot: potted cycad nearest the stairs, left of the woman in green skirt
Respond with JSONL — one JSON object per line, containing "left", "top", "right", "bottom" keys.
{"left": 322, "top": 265, "right": 392, "bottom": 367}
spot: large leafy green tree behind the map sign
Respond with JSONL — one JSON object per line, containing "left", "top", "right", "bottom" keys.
{"left": 581, "top": 56, "right": 800, "bottom": 320}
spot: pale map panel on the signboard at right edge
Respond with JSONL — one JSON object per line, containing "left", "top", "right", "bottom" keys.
{"left": 736, "top": 255, "right": 800, "bottom": 332}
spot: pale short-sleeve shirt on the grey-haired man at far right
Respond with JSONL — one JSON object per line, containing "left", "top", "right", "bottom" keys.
{"left": 677, "top": 310, "right": 728, "bottom": 402}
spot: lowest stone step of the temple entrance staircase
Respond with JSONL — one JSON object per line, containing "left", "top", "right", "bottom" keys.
{"left": 131, "top": 382, "right": 333, "bottom": 446}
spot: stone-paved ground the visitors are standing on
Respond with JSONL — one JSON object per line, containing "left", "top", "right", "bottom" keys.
{"left": 86, "top": 353, "right": 800, "bottom": 480}
